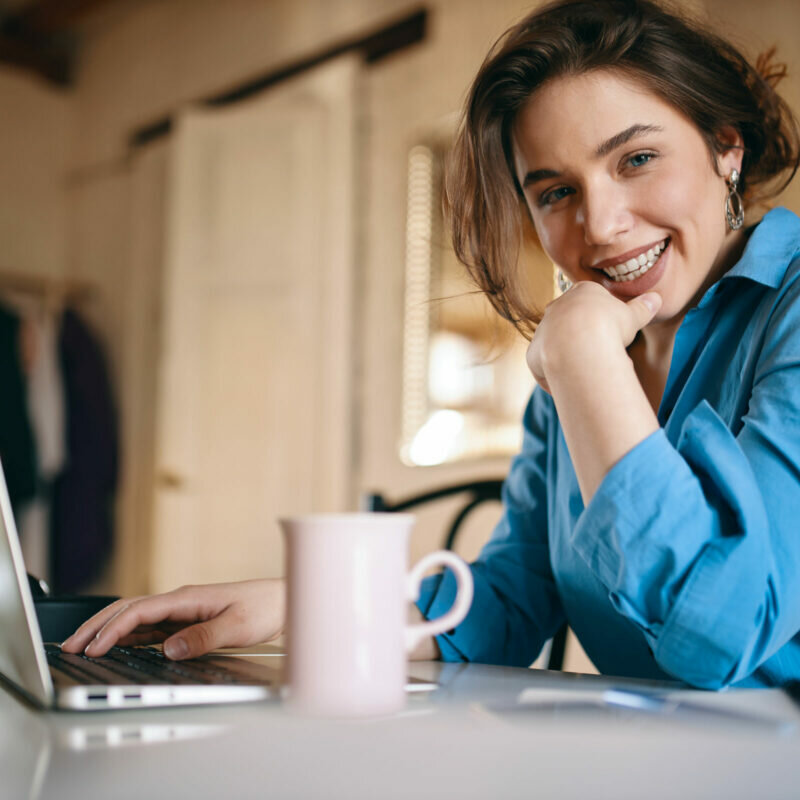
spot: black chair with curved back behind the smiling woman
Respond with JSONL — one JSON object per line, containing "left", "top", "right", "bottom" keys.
{"left": 362, "top": 479, "right": 567, "bottom": 670}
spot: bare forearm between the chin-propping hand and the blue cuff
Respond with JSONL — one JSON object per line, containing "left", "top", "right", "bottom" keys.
{"left": 547, "top": 343, "right": 659, "bottom": 505}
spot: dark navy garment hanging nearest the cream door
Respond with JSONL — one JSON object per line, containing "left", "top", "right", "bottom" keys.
{"left": 50, "top": 309, "right": 118, "bottom": 593}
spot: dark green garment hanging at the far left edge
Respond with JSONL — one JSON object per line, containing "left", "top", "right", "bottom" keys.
{"left": 0, "top": 305, "right": 36, "bottom": 513}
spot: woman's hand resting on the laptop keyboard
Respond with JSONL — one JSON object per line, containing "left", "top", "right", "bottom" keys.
{"left": 61, "top": 579, "right": 286, "bottom": 660}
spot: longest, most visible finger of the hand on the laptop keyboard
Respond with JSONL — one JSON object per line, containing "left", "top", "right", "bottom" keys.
{"left": 84, "top": 588, "right": 217, "bottom": 657}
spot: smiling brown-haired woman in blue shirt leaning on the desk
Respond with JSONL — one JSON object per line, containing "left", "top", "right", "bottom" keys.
{"left": 63, "top": 0, "right": 800, "bottom": 688}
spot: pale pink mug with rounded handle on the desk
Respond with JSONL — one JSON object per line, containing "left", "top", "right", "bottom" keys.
{"left": 280, "top": 512, "right": 472, "bottom": 716}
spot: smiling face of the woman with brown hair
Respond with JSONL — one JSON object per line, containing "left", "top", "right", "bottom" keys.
{"left": 513, "top": 71, "right": 741, "bottom": 321}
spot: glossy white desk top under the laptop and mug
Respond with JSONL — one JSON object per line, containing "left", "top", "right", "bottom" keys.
{"left": 0, "top": 662, "right": 800, "bottom": 800}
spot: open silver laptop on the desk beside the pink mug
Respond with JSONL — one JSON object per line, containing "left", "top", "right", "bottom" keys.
{"left": 0, "top": 464, "right": 436, "bottom": 711}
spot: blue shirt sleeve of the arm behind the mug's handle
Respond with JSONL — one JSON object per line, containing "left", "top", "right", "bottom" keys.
{"left": 417, "top": 389, "right": 564, "bottom": 666}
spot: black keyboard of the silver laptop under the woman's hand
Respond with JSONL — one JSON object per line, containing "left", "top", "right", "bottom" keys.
{"left": 45, "top": 644, "right": 266, "bottom": 686}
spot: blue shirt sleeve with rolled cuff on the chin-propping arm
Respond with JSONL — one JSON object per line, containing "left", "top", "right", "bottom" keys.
{"left": 571, "top": 268, "right": 800, "bottom": 688}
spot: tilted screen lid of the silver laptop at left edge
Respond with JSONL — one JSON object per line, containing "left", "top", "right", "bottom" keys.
{"left": 0, "top": 464, "right": 53, "bottom": 706}
